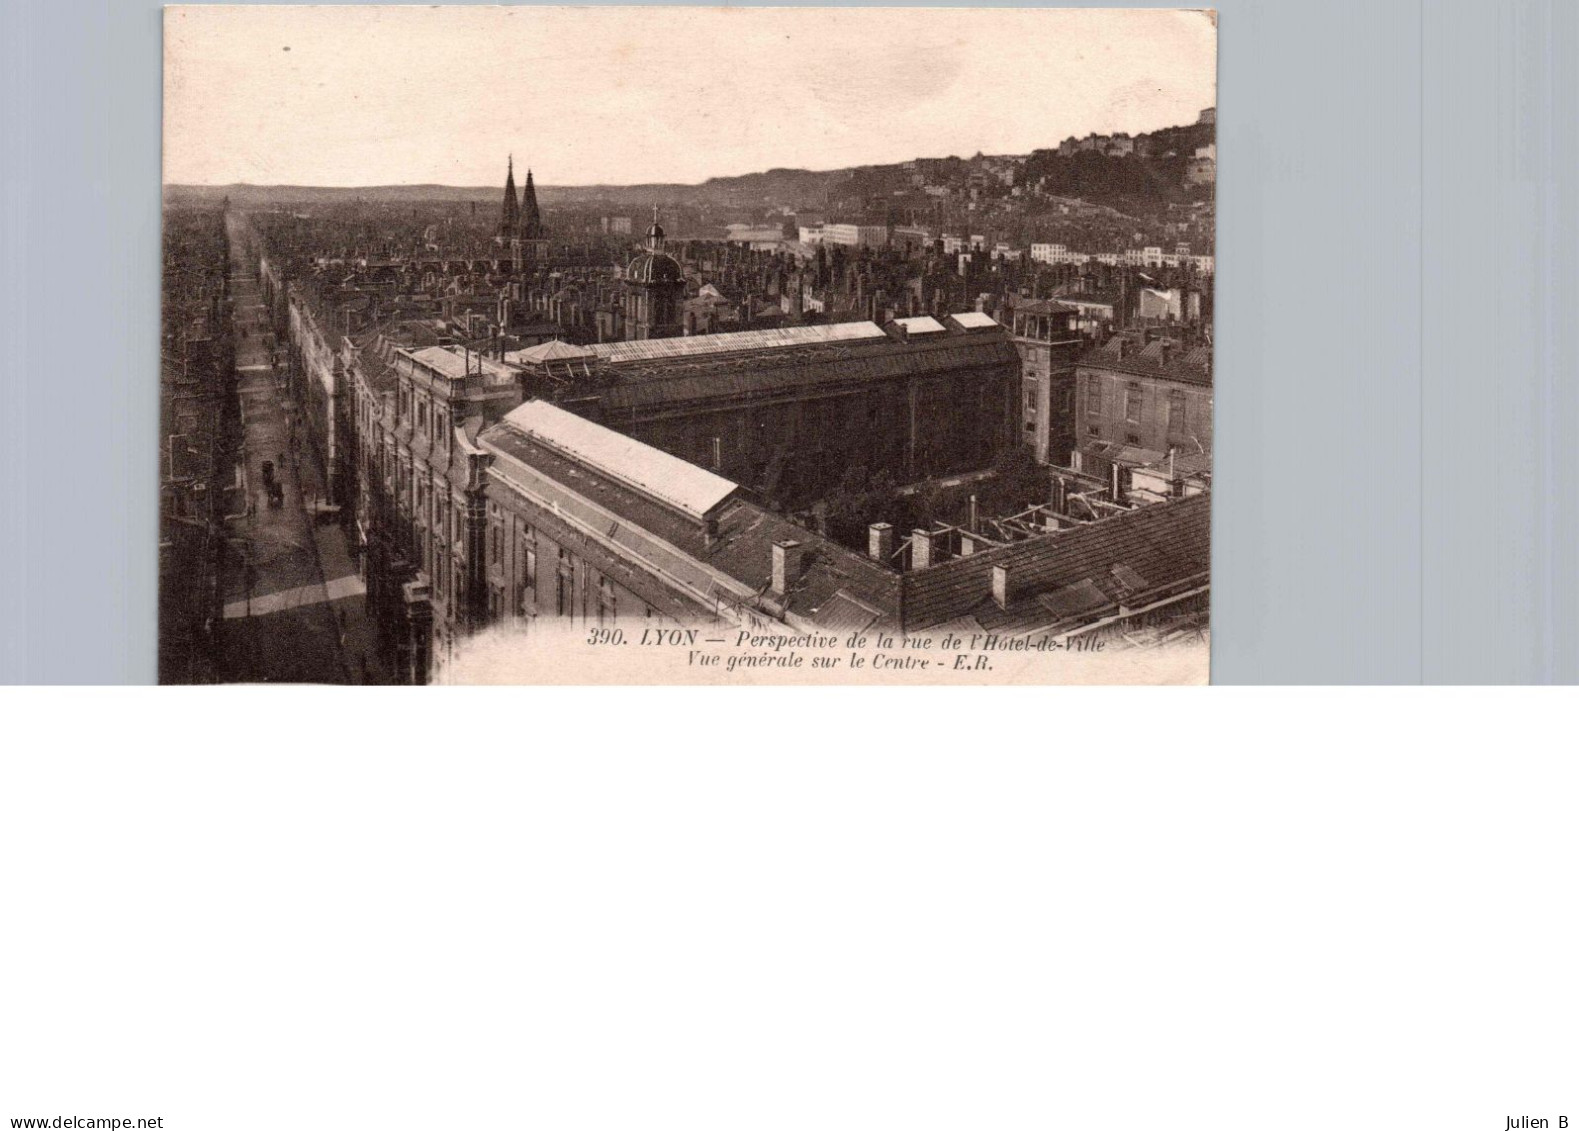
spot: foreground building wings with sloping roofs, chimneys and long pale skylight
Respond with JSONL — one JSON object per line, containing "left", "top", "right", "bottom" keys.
{"left": 478, "top": 401, "right": 1210, "bottom": 640}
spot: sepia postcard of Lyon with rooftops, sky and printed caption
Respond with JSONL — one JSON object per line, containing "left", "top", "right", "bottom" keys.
{"left": 159, "top": 6, "right": 1217, "bottom": 686}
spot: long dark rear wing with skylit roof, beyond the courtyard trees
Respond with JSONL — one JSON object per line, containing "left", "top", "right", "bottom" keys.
{"left": 507, "top": 313, "right": 1020, "bottom": 509}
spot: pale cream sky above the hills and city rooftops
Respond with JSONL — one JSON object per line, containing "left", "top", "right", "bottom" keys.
{"left": 164, "top": 6, "right": 1216, "bottom": 185}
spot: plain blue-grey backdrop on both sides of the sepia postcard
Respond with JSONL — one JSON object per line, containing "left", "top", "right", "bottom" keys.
{"left": 0, "top": 0, "right": 1579, "bottom": 684}
